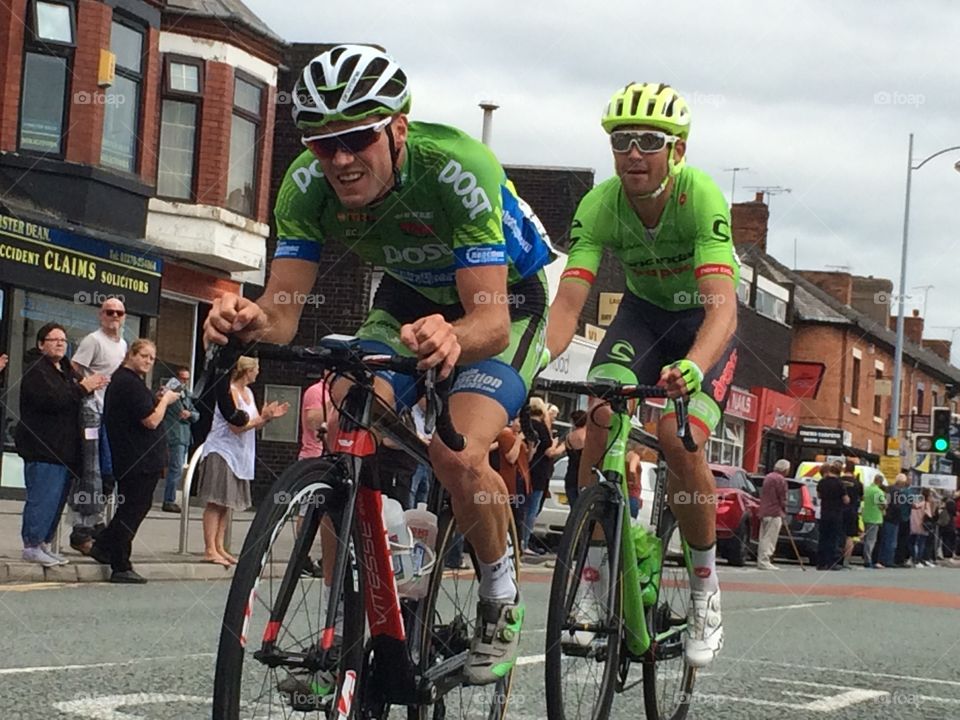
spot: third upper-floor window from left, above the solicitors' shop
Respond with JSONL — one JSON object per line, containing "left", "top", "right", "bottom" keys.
{"left": 157, "top": 57, "right": 203, "bottom": 200}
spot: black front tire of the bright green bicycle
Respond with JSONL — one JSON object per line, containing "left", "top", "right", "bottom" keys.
{"left": 544, "top": 484, "right": 623, "bottom": 720}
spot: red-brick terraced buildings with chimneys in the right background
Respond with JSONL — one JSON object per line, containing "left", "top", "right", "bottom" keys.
{"left": 734, "top": 193, "right": 960, "bottom": 466}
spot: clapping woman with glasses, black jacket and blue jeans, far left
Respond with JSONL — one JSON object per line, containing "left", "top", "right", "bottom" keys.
{"left": 15, "top": 323, "right": 107, "bottom": 567}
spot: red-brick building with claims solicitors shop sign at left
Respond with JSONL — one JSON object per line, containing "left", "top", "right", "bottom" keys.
{"left": 0, "top": 0, "right": 283, "bottom": 496}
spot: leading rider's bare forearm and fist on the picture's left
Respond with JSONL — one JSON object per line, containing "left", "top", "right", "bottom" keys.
{"left": 203, "top": 258, "right": 317, "bottom": 344}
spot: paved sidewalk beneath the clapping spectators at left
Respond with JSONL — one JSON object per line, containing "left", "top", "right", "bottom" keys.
{"left": 0, "top": 500, "right": 254, "bottom": 584}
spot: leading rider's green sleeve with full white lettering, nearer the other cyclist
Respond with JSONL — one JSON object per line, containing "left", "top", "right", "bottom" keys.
{"left": 437, "top": 140, "right": 507, "bottom": 270}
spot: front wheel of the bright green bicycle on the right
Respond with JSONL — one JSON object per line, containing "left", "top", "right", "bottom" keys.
{"left": 545, "top": 485, "right": 623, "bottom": 720}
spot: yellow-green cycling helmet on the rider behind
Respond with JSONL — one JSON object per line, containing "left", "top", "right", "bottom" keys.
{"left": 600, "top": 83, "right": 690, "bottom": 140}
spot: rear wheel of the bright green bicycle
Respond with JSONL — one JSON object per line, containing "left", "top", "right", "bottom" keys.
{"left": 643, "top": 509, "right": 696, "bottom": 720}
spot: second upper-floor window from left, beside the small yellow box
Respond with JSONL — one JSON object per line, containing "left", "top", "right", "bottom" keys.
{"left": 100, "top": 20, "right": 143, "bottom": 173}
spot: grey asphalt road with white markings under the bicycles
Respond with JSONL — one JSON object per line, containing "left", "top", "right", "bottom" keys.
{"left": 0, "top": 568, "right": 960, "bottom": 720}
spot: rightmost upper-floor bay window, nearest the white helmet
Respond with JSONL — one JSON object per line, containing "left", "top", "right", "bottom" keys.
{"left": 227, "top": 76, "right": 264, "bottom": 217}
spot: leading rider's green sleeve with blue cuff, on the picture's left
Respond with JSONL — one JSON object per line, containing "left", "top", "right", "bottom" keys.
{"left": 273, "top": 151, "right": 325, "bottom": 262}
